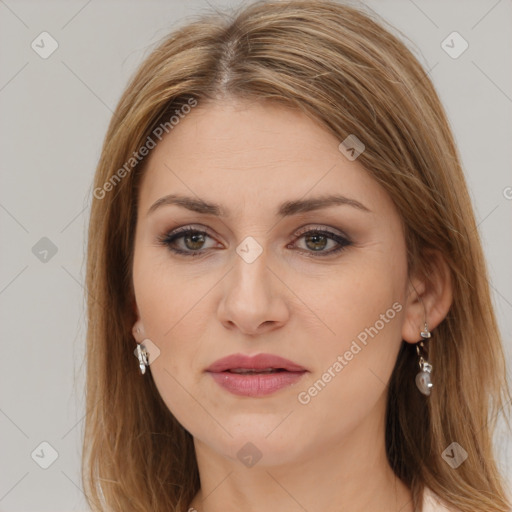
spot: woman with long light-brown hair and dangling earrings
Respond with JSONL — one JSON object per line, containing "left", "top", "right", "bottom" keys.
{"left": 83, "top": 1, "right": 510, "bottom": 512}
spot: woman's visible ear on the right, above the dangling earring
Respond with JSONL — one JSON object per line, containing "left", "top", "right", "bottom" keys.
{"left": 402, "top": 249, "right": 453, "bottom": 343}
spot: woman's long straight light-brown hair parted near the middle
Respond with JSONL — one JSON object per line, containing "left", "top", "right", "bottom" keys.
{"left": 82, "top": 0, "right": 511, "bottom": 512}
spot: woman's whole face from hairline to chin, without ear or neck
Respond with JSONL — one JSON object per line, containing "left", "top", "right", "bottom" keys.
{"left": 133, "top": 98, "right": 414, "bottom": 465}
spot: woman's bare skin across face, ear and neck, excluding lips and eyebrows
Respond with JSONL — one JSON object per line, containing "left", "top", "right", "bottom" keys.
{"left": 133, "top": 100, "right": 451, "bottom": 512}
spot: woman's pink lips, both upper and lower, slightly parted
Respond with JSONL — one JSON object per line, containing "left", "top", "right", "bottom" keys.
{"left": 206, "top": 354, "right": 308, "bottom": 398}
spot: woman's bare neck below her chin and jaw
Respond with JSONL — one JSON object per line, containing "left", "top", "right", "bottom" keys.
{"left": 186, "top": 398, "right": 413, "bottom": 512}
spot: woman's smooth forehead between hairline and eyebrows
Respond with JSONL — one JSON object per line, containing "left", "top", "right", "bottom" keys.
{"left": 139, "top": 101, "right": 392, "bottom": 217}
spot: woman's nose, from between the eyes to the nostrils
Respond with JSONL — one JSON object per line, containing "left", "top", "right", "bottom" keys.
{"left": 218, "top": 243, "right": 289, "bottom": 336}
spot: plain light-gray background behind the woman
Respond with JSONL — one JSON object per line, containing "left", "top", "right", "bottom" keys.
{"left": 0, "top": 0, "right": 512, "bottom": 512}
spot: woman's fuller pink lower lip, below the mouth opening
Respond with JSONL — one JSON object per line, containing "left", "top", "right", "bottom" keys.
{"left": 209, "top": 370, "right": 306, "bottom": 397}
